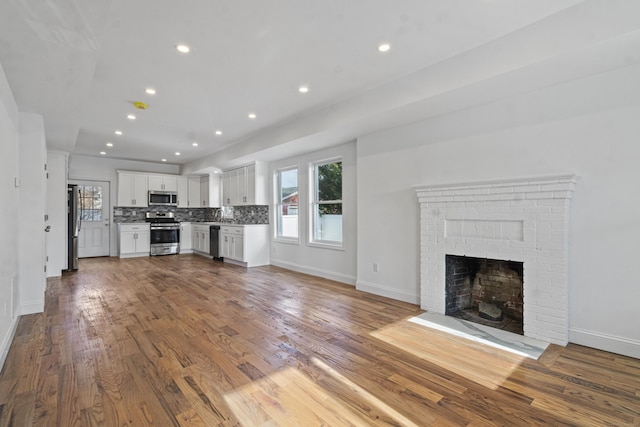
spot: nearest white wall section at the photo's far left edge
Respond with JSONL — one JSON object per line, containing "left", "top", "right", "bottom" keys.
{"left": 0, "top": 61, "right": 20, "bottom": 365}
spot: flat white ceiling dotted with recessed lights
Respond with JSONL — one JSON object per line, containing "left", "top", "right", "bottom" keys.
{"left": 0, "top": 0, "right": 581, "bottom": 169}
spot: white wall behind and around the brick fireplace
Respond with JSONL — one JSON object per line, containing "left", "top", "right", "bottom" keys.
{"left": 357, "top": 56, "right": 640, "bottom": 357}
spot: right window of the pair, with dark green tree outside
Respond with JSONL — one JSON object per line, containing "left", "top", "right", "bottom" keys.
{"left": 310, "top": 159, "right": 342, "bottom": 246}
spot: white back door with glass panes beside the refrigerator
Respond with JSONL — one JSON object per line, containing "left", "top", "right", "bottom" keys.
{"left": 72, "top": 181, "right": 111, "bottom": 258}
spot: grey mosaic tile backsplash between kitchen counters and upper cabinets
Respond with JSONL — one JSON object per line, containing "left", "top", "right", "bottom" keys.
{"left": 113, "top": 205, "right": 269, "bottom": 224}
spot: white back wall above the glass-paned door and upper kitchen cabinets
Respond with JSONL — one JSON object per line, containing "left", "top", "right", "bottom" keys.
{"left": 69, "top": 154, "right": 179, "bottom": 256}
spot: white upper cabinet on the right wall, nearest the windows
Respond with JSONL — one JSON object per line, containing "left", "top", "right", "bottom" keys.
{"left": 222, "top": 162, "right": 268, "bottom": 206}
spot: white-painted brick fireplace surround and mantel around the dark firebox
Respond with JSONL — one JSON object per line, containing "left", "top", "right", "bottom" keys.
{"left": 416, "top": 175, "right": 576, "bottom": 345}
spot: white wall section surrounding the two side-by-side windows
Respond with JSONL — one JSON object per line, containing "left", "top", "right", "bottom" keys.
{"left": 269, "top": 142, "right": 357, "bottom": 284}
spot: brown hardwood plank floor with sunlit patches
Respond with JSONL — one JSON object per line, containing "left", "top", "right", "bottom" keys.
{"left": 0, "top": 255, "right": 640, "bottom": 427}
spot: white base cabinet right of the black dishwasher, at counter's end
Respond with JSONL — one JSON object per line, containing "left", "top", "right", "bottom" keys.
{"left": 220, "top": 224, "right": 270, "bottom": 267}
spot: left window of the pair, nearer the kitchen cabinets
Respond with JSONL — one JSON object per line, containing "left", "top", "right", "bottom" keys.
{"left": 276, "top": 168, "right": 299, "bottom": 239}
